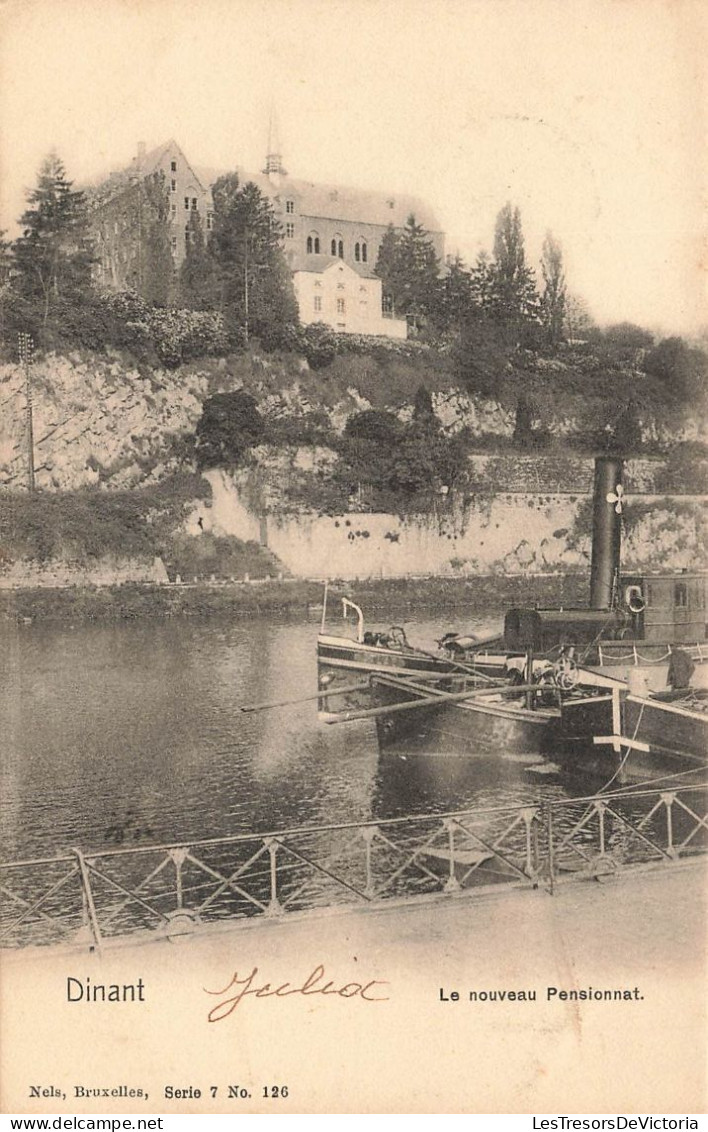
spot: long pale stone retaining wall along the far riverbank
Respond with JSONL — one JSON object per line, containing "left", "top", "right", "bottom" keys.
{"left": 201, "top": 472, "right": 708, "bottom": 578}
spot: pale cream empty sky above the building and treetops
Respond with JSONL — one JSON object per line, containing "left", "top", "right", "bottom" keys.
{"left": 0, "top": 0, "right": 708, "bottom": 334}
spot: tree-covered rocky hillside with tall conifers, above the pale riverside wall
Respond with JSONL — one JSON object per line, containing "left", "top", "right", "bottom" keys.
{"left": 0, "top": 155, "right": 708, "bottom": 573}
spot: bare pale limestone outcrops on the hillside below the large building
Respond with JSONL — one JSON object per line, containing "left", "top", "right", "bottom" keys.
{"left": 0, "top": 353, "right": 708, "bottom": 491}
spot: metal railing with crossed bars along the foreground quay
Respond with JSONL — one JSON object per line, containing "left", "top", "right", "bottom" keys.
{"left": 0, "top": 786, "right": 708, "bottom": 949}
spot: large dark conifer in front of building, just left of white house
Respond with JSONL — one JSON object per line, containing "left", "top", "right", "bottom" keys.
{"left": 208, "top": 173, "right": 298, "bottom": 346}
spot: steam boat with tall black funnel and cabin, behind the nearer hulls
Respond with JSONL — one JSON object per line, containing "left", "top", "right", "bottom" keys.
{"left": 317, "top": 456, "right": 708, "bottom": 692}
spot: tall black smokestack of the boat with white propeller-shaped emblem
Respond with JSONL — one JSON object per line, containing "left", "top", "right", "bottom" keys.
{"left": 590, "top": 456, "right": 623, "bottom": 609}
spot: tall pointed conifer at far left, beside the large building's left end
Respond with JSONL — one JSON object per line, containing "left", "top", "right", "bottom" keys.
{"left": 14, "top": 153, "right": 94, "bottom": 328}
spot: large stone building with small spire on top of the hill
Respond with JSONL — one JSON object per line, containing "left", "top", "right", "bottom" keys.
{"left": 92, "top": 130, "right": 444, "bottom": 337}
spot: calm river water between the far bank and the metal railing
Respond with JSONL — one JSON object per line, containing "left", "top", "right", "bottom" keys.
{"left": 0, "top": 617, "right": 602, "bottom": 860}
